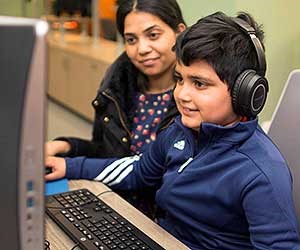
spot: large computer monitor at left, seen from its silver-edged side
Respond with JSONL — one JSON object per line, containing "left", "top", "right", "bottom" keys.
{"left": 0, "top": 16, "right": 48, "bottom": 250}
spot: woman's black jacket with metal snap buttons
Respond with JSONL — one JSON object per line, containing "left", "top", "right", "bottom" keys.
{"left": 56, "top": 53, "right": 178, "bottom": 158}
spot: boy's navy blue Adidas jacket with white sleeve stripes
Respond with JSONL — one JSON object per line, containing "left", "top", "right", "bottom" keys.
{"left": 67, "top": 117, "right": 300, "bottom": 250}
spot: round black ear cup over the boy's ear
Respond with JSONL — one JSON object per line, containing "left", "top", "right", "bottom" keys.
{"left": 231, "top": 70, "right": 269, "bottom": 118}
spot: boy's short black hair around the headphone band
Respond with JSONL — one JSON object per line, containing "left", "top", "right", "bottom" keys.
{"left": 175, "top": 12, "right": 264, "bottom": 90}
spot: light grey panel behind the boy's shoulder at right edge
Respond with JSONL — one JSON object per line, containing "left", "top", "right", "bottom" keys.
{"left": 268, "top": 69, "right": 300, "bottom": 229}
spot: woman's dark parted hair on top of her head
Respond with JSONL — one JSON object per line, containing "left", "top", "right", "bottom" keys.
{"left": 117, "top": 0, "right": 185, "bottom": 36}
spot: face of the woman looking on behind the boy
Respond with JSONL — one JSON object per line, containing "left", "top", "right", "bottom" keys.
{"left": 124, "top": 11, "right": 176, "bottom": 77}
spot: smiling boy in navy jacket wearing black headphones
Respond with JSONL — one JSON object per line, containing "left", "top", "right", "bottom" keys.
{"left": 46, "top": 12, "right": 300, "bottom": 250}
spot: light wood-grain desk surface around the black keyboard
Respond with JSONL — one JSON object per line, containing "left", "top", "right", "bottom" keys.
{"left": 46, "top": 180, "right": 188, "bottom": 250}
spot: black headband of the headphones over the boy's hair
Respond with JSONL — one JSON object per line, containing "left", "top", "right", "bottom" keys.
{"left": 233, "top": 17, "right": 267, "bottom": 76}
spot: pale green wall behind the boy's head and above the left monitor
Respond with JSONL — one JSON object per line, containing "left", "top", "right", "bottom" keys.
{"left": 0, "top": 0, "right": 300, "bottom": 121}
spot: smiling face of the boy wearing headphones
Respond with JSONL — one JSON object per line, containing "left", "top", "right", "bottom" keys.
{"left": 174, "top": 60, "right": 241, "bottom": 131}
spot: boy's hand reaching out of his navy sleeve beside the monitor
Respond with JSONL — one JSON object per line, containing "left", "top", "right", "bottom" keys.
{"left": 45, "top": 156, "right": 66, "bottom": 181}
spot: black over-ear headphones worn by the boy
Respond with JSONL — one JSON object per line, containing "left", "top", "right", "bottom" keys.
{"left": 231, "top": 18, "right": 269, "bottom": 118}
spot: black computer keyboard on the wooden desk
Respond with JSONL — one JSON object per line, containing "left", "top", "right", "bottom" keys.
{"left": 46, "top": 189, "right": 164, "bottom": 250}
